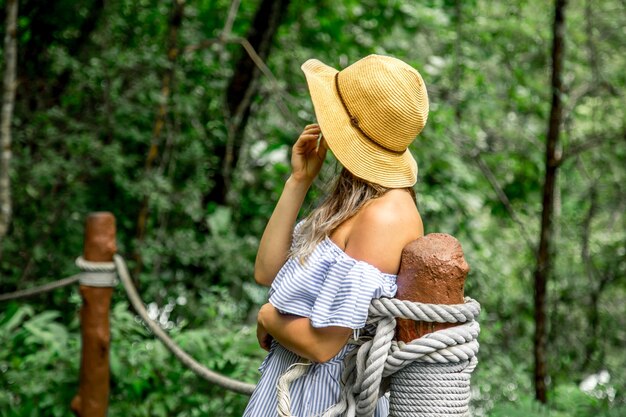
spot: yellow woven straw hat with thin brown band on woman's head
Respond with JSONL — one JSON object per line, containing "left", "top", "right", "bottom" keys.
{"left": 302, "top": 55, "right": 428, "bottom": 188}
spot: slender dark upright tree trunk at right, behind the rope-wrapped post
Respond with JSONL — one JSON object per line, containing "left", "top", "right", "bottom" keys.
{"left": 534, "top": 0, "right": 567, "bottom": 403}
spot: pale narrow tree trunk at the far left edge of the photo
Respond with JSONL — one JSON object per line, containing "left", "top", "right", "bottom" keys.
{"left": 0, "top": 0, "right": 17, "bottom": 242}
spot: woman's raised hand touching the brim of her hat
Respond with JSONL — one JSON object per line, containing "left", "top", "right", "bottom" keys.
{"left": 291, "top": 124, "right": 328, "bottom": 183}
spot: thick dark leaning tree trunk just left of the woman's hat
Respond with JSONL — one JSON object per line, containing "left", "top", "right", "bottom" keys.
{"left": 204, "top": 0, "right": 290, "bottom": 204}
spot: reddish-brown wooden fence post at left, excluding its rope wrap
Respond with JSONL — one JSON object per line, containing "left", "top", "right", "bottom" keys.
{"left": 71, "top": 212, "right": 117, "bottom": 417}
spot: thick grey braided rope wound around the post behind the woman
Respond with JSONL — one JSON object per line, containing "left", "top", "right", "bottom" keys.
{"left": 344, "top": 298, "right": 480, "bottom": 417}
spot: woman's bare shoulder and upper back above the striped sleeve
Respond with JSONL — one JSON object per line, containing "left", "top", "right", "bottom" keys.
{"left": 345, "top": 190, "right": 424, "bottom": 274}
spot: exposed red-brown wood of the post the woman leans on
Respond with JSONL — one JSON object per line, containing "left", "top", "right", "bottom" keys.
{"left": 396, "top": 233, "right": 469, "bottom": 343}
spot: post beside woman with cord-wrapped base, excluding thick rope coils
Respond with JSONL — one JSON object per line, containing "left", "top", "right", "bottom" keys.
{"left": 389, "top": 233, "right": 468, "bottom": 417}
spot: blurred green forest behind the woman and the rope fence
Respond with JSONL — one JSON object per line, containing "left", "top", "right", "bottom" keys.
{"left": 0, "top": 0, "right": 626, "bottom": 417}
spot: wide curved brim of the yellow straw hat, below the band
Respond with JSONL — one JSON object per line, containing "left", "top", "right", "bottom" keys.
{"left": 301, "top": 59, "right": 417, "bottom": 188}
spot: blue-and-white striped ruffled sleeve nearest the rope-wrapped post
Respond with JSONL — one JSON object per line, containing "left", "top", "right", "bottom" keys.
{"left": 309, "top": 257, "right": 396, "bottom": 329}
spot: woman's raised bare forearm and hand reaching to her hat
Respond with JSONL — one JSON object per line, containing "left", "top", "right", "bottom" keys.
{"left": 254, "top": 124, "right": 328, "bottom": 286}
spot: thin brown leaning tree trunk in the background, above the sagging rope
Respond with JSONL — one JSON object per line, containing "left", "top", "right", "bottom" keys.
{"left": 133, "top": 0, "right": 185, "bottom": 279}
